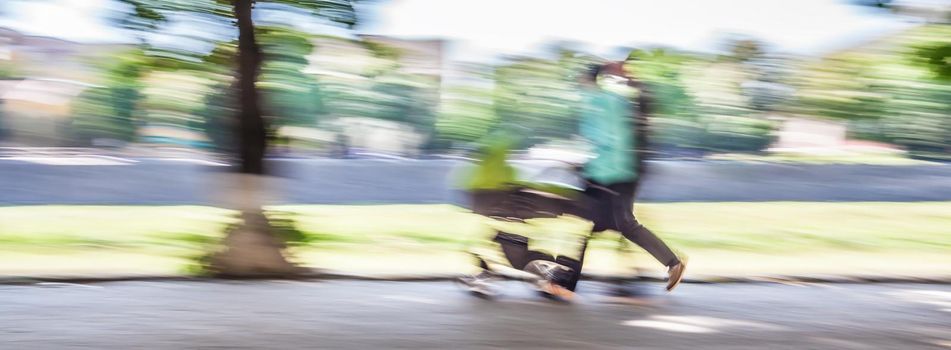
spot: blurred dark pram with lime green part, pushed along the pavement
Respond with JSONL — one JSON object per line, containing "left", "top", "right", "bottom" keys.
{"left": 463, "top": 133, "right": 644, "bottom": 297}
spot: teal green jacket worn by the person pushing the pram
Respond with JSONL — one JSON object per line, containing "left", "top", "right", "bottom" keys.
{"left": 579, "top": 89, "right": 637, "bottom": 185}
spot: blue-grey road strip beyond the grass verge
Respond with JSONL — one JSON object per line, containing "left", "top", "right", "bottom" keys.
{"left": 0, "top": 158, "right": 951, "bottom": 205}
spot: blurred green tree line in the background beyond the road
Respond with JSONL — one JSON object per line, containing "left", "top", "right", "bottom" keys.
{"left": 59, "top": 1, "right": 951, "bottom": 157}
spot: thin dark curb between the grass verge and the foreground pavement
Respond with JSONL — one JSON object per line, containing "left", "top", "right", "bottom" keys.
{"left": 0, "top": 271, "right": 951, "bottom": 285}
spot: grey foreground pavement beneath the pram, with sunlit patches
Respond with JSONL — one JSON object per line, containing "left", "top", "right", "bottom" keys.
{"left": 0, "top": 281, "right": 951, "bottom": 349}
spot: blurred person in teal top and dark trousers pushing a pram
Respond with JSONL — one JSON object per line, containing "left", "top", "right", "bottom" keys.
{"left": 564, "top": 64, "right": 686, "bottom": 291}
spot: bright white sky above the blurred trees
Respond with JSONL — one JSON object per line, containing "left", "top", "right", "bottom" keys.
{"left": 0, "top": 0, "right": 924, "bottom": 61}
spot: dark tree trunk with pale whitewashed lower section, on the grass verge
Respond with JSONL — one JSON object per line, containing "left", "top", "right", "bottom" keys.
{"left": 209, "top": 0, "right": 301, "bottom": 277}
